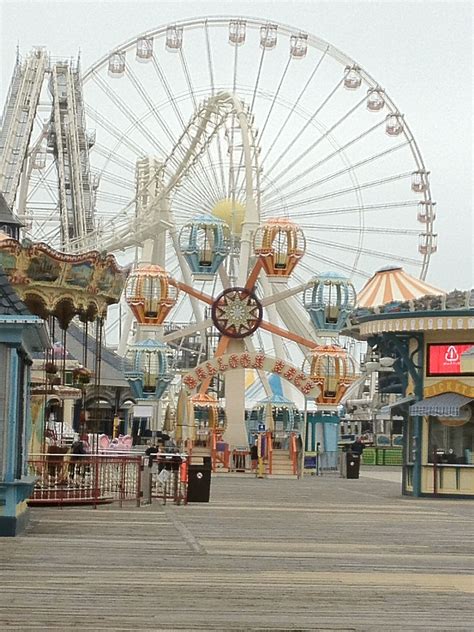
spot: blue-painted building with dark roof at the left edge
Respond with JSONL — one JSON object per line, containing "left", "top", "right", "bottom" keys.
{"left": 0, "top": 268, "right": 49, "bottom": 536}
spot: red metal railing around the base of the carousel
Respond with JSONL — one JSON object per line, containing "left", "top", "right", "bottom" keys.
{"left": 28, "top": 454, "right": 142, "bottom": 506}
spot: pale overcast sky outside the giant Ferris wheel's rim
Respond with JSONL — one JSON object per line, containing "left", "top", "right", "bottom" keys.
{"left": 0, "top": 0, "right": 474, "bottom": 289}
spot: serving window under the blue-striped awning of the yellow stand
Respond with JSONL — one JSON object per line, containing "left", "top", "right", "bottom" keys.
{"left": 428, "top": 417, "right": 474, "bottom": 465}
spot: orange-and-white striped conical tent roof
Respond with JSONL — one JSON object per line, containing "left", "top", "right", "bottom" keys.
{"left": 357, "top": 267, "right": 446, "bottom": 307}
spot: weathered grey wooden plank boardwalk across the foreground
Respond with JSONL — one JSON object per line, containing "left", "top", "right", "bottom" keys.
{"left": 0, "top": 469, "right": 474, "bottom": 632}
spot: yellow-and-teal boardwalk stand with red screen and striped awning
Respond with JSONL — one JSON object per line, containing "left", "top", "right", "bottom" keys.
{"left": 350, "top": 266, "right": 474, "bottom": 497}
